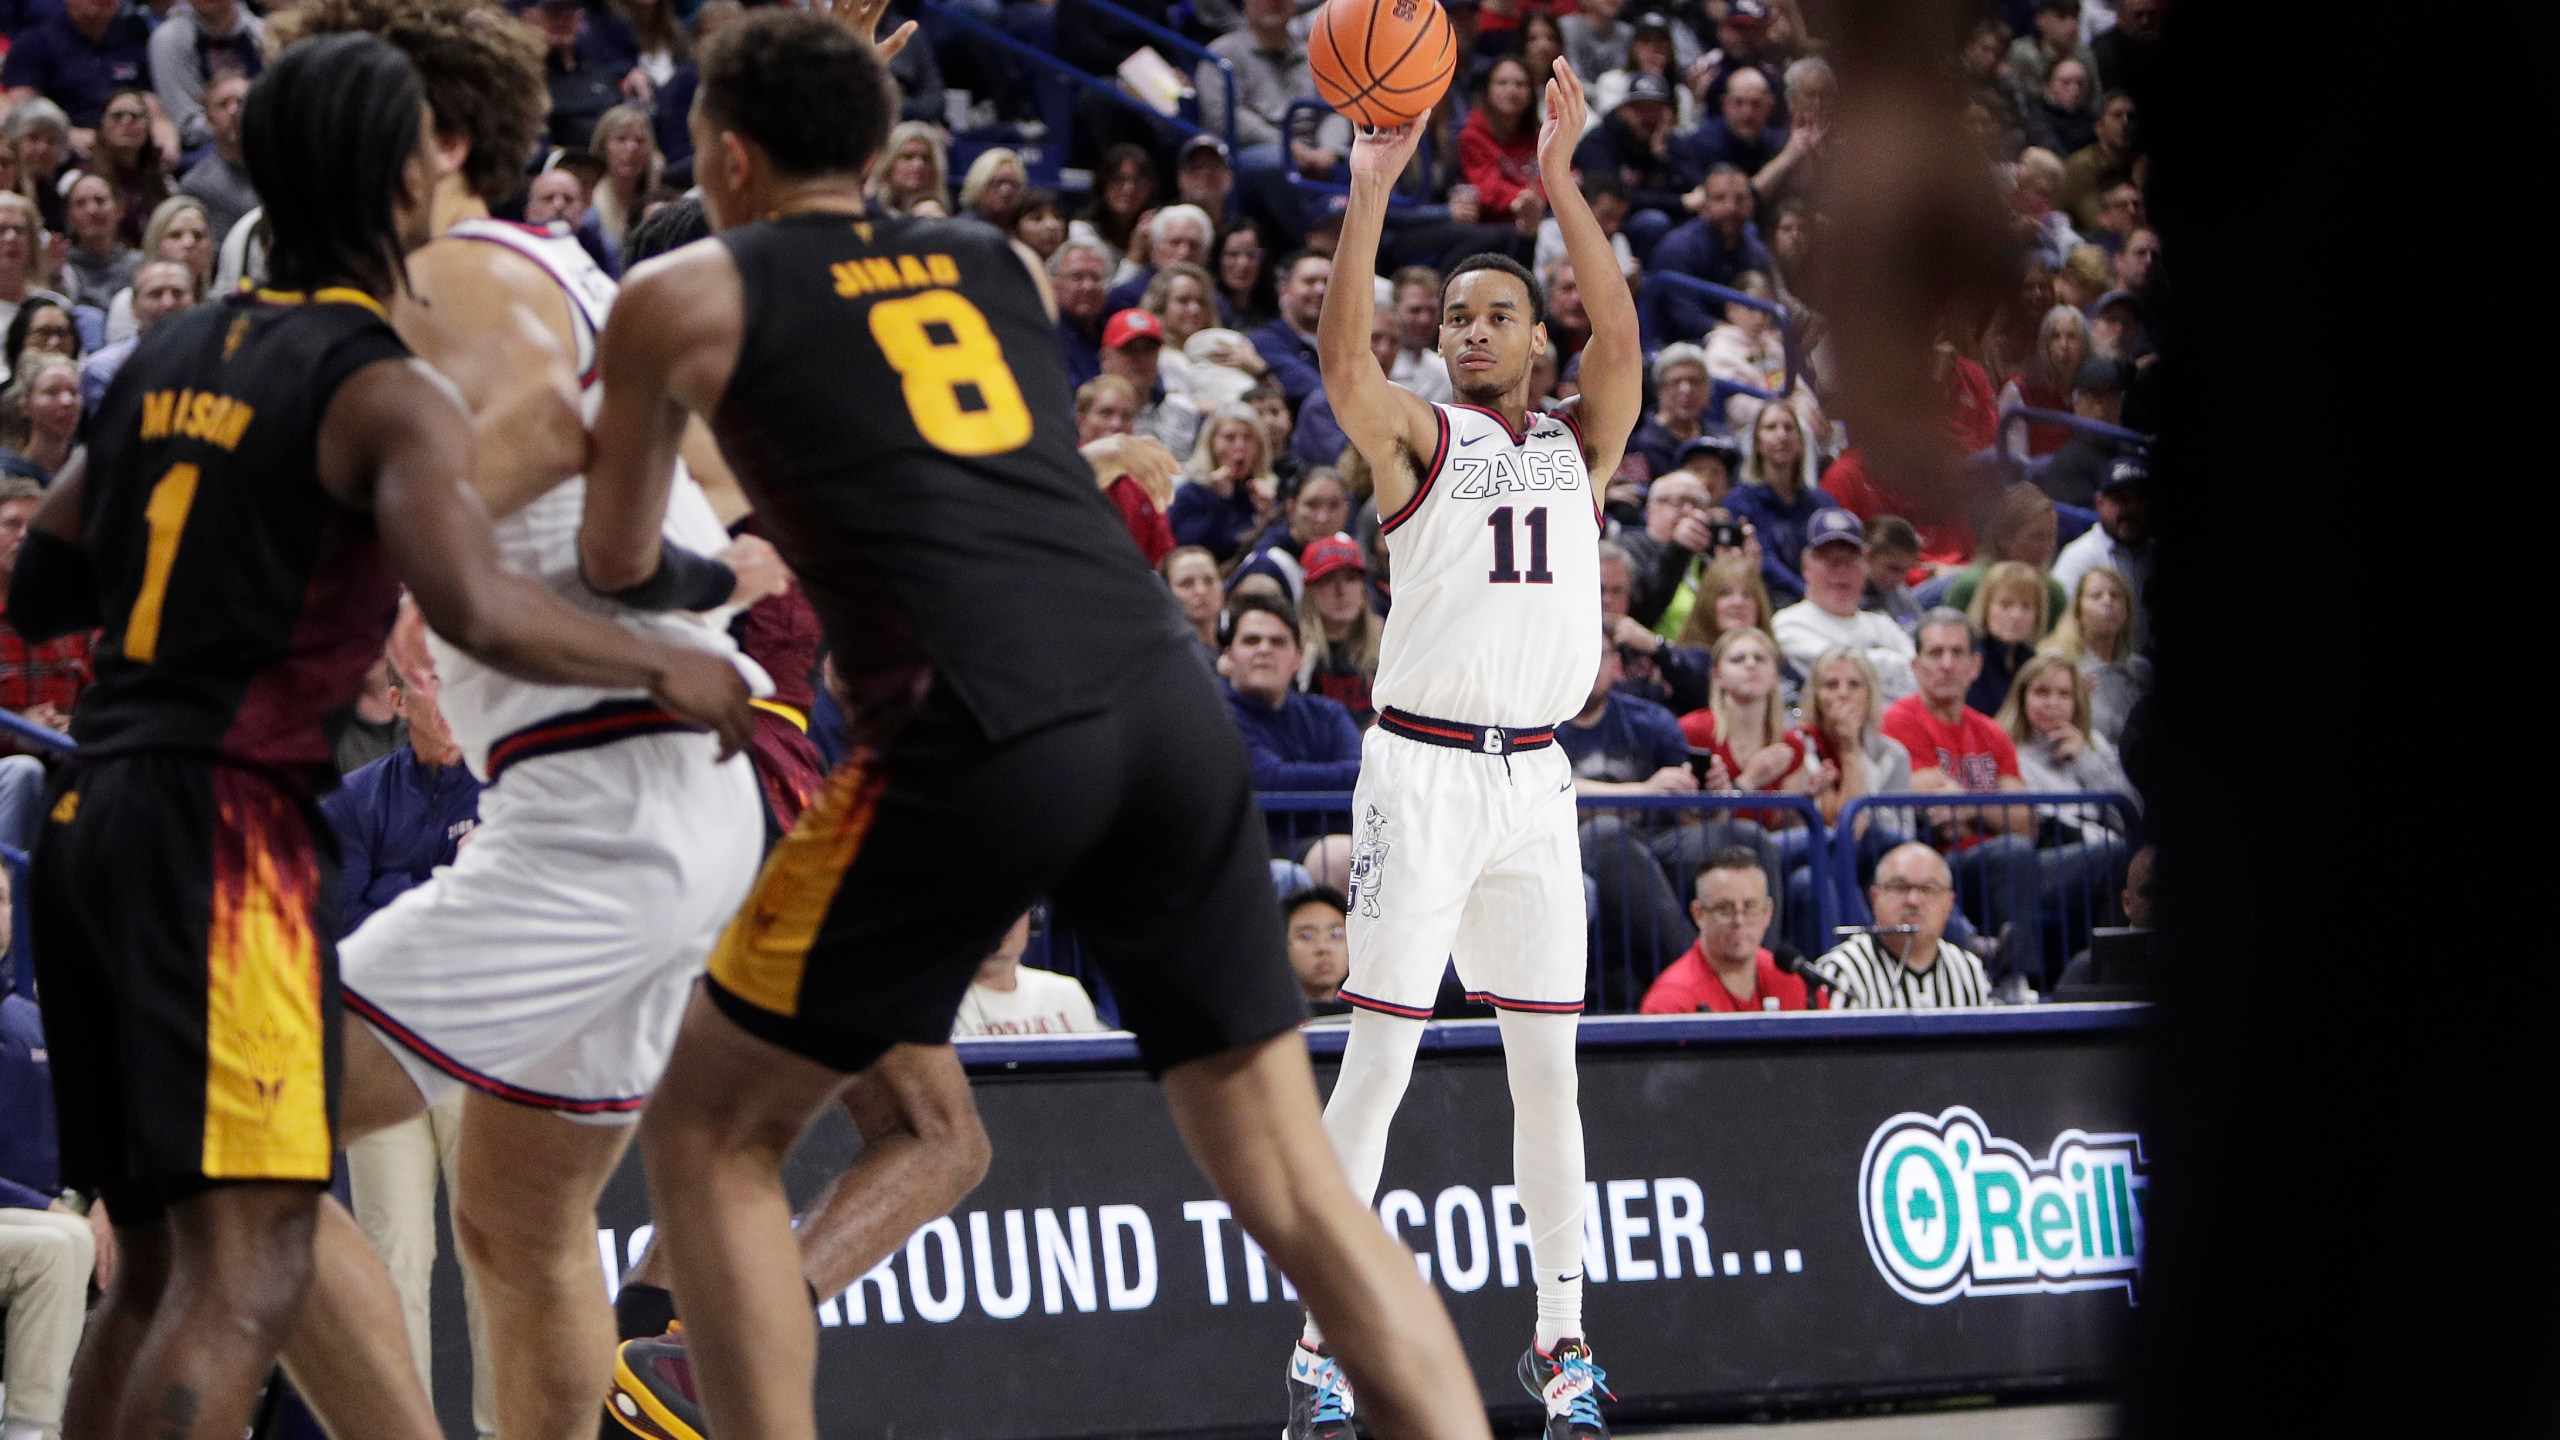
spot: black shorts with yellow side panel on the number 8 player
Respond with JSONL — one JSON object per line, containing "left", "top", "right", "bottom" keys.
{"left": 707, "top": 648, "right": 1306, "bottom": 1074}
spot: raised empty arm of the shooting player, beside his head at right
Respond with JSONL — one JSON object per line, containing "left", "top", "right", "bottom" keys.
{"left": 1539, "top": 56, "right": 1644, "bottom": 481}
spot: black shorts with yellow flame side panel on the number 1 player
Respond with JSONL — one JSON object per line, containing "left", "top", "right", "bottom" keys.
{"left": 28, "top": 753, "right": 340, "bottom": 1222}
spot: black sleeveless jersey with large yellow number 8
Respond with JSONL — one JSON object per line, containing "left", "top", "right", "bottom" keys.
{"left": 712, "top": 215, "right": 1188, "bottom": 740}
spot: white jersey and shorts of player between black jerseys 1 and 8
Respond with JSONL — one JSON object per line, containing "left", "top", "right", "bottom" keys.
{"left": 338, "top": 220, "right": 771, "bottom": 1122}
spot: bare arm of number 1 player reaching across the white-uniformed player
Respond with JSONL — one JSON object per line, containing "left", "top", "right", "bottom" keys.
{"left": 320, "top": 361, "right": 755, "bottom": 753}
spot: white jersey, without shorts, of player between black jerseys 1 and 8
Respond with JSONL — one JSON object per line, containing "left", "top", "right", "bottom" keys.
{"left": 428, "top": 220, "right": 760, "bottom": 781}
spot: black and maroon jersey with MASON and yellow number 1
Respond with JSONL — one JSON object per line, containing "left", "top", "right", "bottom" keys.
{"left": 72, "top": 290, "right": 410, "bottom": 787}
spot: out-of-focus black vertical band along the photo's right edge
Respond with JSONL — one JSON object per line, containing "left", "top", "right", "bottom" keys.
{"left": 2127, "top": 0, "right": 2560, "bottom": 1440}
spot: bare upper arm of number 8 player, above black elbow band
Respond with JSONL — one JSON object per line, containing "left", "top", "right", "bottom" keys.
{"left": 579, "top": 241, "right": 745, "bottom": 594}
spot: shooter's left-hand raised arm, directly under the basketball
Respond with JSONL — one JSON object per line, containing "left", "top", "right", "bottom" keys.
{"left": 1316, "top": 123, "right": 1434, "bottom": 515}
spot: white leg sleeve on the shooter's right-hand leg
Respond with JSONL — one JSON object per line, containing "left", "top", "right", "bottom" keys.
{"left": 1500, "top": 1010, "right": 1585, "bottom": 1350}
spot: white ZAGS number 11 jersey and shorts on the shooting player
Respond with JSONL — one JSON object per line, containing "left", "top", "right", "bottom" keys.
{"left": 1341, "top": 405, "right": 1600, "bottom": 1020}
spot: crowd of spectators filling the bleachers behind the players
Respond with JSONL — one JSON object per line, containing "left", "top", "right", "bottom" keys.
{"left": 0, "top": 0, "right": 2168, "bottom": 1019}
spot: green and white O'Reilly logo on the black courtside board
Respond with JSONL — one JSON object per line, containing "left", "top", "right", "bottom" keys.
{"left": 1859, "top": 1104, "right": 2148, "bottom": 1304}
